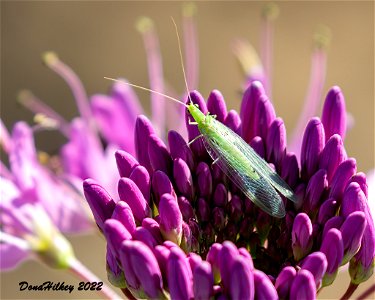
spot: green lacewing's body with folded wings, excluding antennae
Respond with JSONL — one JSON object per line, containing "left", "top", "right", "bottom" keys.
{"left": 187, "top": 103, "right": 297, "bottom": 218}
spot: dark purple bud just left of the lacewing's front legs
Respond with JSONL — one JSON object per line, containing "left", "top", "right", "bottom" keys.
{"left": 168, "top": 130, "right": 194, "bottom": 170}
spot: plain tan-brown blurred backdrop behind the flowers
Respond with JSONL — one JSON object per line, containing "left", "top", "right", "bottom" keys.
{"left": 1, "top": 1, "right": 374, "bottom": 299}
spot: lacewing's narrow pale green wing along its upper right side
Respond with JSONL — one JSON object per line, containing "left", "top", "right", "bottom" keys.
{"left": 204, "top": 119, "right": 298, "bottom": 203}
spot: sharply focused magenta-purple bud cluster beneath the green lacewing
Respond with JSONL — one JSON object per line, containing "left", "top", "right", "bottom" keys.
{"left": 84, "top": 82, "right": 375, "bottom": 299}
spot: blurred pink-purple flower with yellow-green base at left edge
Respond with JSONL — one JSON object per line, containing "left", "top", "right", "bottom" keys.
{"left": 0, "top": 122, "right": 93, "bottom": 269}
